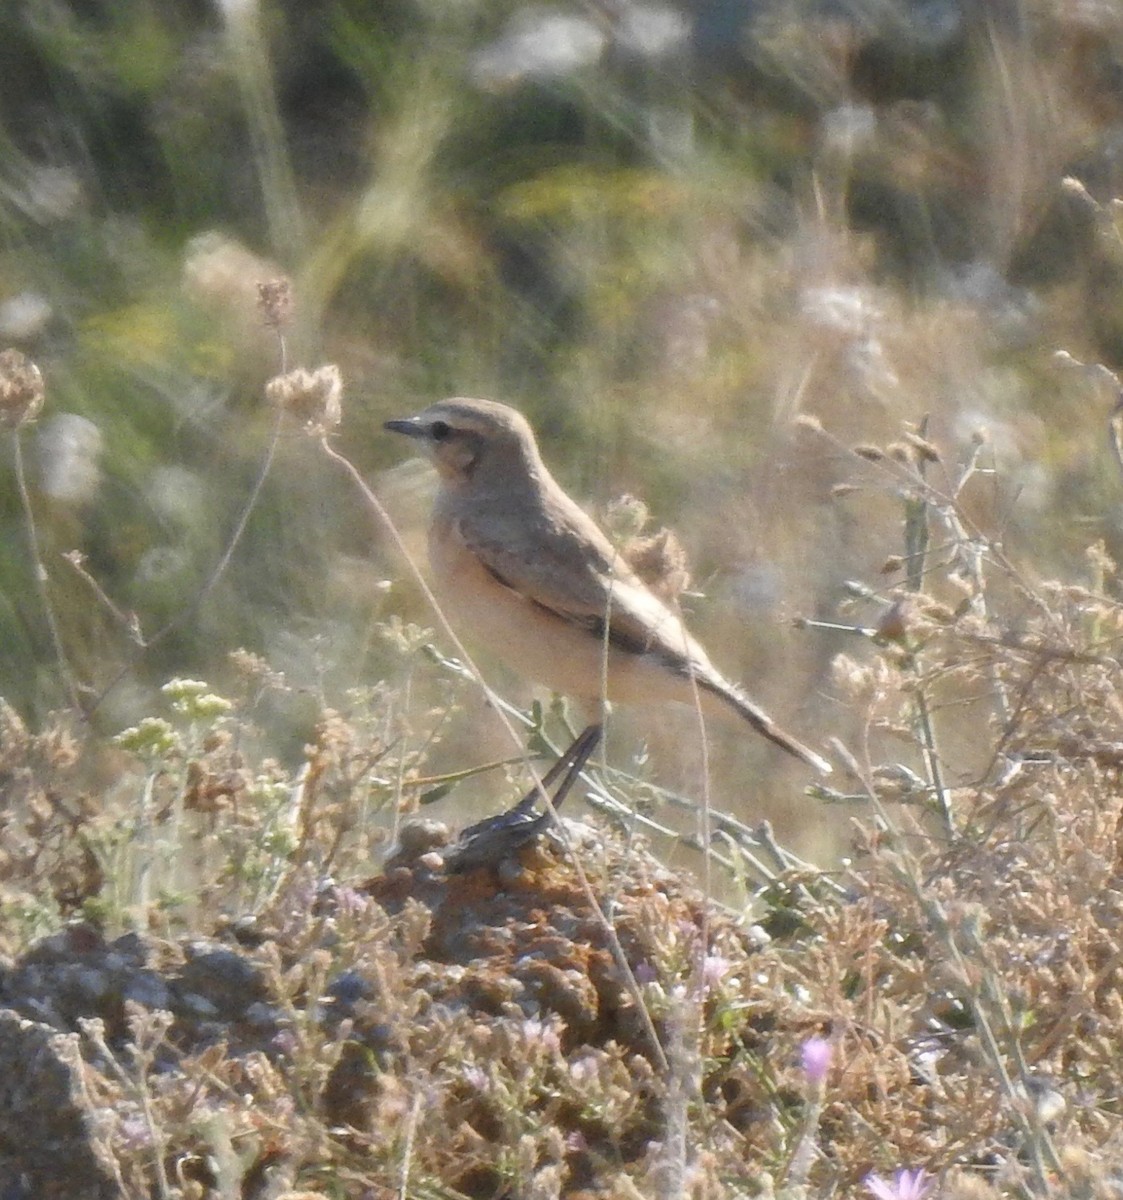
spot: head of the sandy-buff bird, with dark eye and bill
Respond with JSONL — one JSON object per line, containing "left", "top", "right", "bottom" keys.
{"left": 383, "top": 398, "right": 539, "bottom": 482}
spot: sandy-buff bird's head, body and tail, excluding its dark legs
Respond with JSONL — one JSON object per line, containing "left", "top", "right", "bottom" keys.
{"left": 385, "top": 400, "right": 830, "bottom": 774}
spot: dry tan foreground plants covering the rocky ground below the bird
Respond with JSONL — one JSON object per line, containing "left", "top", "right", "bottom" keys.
{"left": 0, "top": 410, "right": 1123, "bottom": 1198}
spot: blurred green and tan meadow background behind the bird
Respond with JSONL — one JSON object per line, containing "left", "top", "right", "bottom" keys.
{"left": 0, "top": 0, "right": 1123, "bottom": 852}
